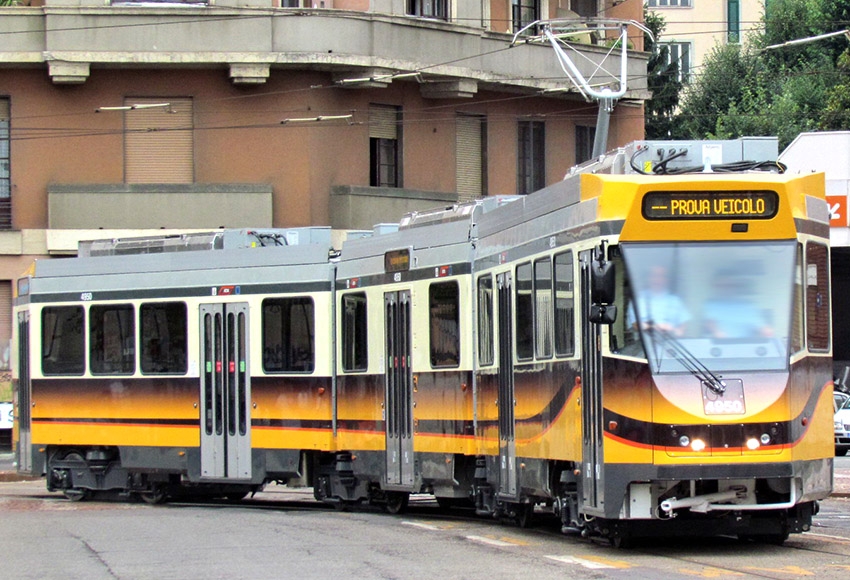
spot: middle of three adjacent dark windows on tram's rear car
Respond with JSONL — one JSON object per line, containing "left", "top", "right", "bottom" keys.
{"left": 89, "top": 304, "right": 136, "bottom": 375}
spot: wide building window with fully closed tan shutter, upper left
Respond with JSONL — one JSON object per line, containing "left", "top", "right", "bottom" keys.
{"left": 124, "top": 97, "right": 194, "bottom": 183}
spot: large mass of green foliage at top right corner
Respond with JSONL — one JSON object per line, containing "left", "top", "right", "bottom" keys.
{"left": 673, "top": 0, "right": 850, "bottom": 148}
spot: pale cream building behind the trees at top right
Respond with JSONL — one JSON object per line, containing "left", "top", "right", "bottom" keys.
{"left": 646, "top": 0, "right": 764, "bottom": 81}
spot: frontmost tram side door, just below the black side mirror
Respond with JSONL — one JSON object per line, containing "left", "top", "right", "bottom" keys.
{"left": 579, "top": 251, "right": 604, "bottom": 508}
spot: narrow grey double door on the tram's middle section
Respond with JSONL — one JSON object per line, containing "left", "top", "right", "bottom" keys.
{"left": 384, "top": 290, "right": 414, "bottom": 487}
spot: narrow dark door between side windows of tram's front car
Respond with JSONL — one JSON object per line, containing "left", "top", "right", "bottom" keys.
{"left": 496, "top": 272, "right": 517, "bottom": 498}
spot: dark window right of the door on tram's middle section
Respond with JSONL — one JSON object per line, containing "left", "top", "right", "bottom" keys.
{"left": 428, "top": 282, "right": 460, "bottom": 367}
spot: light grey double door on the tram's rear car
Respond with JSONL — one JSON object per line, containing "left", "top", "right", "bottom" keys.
{"left": 200, "top": 302, "right": 251, "bottom": 479}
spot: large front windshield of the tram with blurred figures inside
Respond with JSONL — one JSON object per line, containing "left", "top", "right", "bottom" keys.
{"left": 620, "top": 241, "right": 796, "bottom": 374}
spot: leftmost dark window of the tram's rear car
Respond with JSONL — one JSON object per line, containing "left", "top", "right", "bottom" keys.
{"left": 41, "top": 306, "right": 86, "bottom": 375}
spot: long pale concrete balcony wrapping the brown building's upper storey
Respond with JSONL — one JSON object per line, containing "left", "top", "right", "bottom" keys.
{"left": 0, "top": 7, "right": 649, "bottom": 99}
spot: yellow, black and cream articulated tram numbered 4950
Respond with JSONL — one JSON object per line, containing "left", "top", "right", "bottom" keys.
{"left": 14, "top": 144, "right": 833, "bottom": 544}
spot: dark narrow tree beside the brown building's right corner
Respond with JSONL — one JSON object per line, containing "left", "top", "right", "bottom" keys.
{"left": 643, "top": 7, "right": 682, "bottom": 139}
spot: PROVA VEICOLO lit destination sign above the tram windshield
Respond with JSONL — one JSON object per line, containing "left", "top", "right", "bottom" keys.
{"left": 643, "top": 191, "right": 779, "bottom": 220}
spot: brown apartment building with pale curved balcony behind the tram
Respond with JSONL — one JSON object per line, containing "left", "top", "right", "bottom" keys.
{"left": 0, "top": 0, "right": 650, "bottom": 358}
